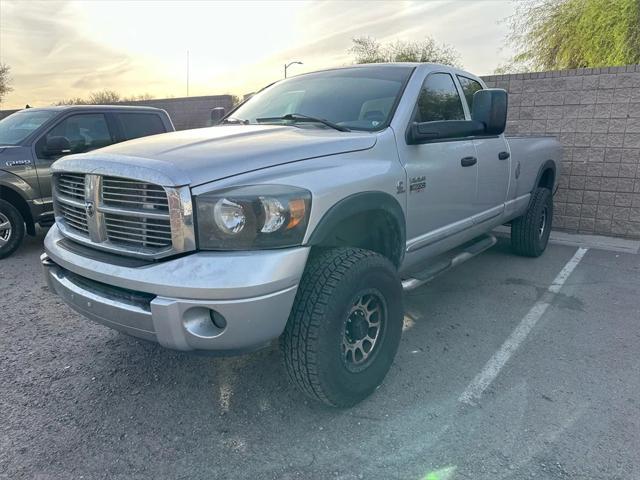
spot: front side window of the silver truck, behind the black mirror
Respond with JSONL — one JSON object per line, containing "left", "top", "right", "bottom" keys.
{"left": 414, "top": 73, "right": 465, "bottom": 122}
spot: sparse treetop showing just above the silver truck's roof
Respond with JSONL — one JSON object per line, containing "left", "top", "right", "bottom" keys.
{"left": 349, "top": 36, "right": 460, "bottom": 65}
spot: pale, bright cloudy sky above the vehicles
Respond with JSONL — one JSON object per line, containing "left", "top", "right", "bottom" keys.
{"left": 0, "top": 0, "right": 515, "bottom": 109}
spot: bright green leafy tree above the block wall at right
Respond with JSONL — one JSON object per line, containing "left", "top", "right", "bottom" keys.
{"left": 500, "top": 0, "right": 640, "bottom": 71}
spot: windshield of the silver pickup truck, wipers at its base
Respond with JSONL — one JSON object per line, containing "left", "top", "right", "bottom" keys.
{"left": 228, "top": 66, "right": 413, "bottom": 131}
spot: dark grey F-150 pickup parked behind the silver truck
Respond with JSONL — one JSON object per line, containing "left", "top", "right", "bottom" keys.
{"left": 0, "top": 105, "right": 174, "bottom": 259}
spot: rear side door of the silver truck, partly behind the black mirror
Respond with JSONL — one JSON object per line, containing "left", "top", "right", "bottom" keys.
{"left": 457, "top": 75, "right": 511, "bottom": 221}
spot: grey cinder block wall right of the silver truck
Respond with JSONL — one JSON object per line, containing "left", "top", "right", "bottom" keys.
{"left": 484, "top": 65, "right": 640, "bottom": 238}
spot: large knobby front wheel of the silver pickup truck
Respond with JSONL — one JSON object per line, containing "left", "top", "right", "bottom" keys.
{"left": 281, "top": 248, "right": 403, "bottom": 407}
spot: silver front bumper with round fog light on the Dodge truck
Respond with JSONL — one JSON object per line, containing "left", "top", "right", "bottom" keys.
{"left": 41, "top": 226, "right": 309, "bottom": 351}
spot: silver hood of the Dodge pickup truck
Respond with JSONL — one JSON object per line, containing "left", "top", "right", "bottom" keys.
{"left": 54, "top": 125, "right": 376, "bottom": 186}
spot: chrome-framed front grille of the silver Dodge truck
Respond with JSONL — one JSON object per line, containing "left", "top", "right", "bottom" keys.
{"left": 53, "top": 172, "right": 195, "bottom": 258}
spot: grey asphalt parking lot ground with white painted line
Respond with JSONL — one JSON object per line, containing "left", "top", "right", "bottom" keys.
{"left": 0, "top": 230, "right": 640, "bottom": 480}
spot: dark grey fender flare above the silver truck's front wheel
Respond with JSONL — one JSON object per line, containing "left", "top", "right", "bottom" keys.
{"left": 307, "top": 191, "right": 407, "bottom": 264}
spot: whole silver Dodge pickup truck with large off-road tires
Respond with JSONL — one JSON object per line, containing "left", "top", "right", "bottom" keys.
{"left": 42, "top": 64, "right": 561, "bottom": 407}
